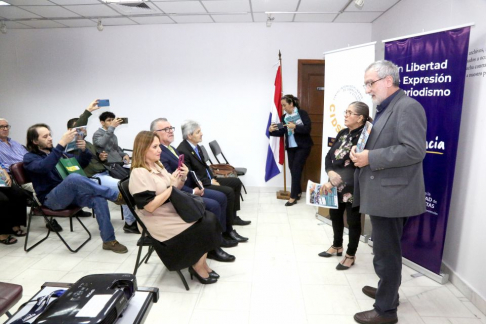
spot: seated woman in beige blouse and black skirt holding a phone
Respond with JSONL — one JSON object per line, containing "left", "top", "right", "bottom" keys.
{"left": 129, "top": 131, "right": 221, "bottom": 284}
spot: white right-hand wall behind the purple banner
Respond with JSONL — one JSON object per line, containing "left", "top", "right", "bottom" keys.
{"left": 372, "top": 0, "right": 486, "bottom": 304}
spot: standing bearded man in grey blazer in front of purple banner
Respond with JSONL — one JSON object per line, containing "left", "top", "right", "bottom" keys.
{"left": 350, "top": 61, "right": 427, "bottom": 324}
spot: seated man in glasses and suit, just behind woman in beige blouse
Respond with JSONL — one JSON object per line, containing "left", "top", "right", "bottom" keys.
{"left": 150, "top": 118, "right": 238, "bottom": 262}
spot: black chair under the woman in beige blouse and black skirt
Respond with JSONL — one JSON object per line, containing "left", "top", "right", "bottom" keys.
{"left": 118, "top": 178, "right": 189, "bottom": 290}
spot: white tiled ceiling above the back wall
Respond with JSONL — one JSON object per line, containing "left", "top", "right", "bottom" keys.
{"left": 0, "top": 0, "right": 401, "bottom": 29}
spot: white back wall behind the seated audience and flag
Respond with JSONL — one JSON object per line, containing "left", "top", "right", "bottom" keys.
{"left": 0, "top": 23, "right": 371, "bottom": 186}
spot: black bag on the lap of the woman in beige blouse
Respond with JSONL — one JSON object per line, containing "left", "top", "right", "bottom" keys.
{"left": 169, "top": 187, "right": 206, "bottom": 223}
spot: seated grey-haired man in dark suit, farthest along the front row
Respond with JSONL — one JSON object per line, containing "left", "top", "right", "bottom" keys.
{"left": 177, "top": 121, "right": 251, "bottom": 242}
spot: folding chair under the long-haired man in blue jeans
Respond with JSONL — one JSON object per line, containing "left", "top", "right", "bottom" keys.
{"left": 10, "top": 162, "right": 91, "bottom": 253}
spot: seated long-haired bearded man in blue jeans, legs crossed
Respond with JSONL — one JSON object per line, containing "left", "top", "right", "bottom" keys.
{"left": 24, "top": 124, "right": 128, "bottom": 253}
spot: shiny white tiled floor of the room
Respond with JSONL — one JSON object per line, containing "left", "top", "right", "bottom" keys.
{"left": 0, "top": 191, "right": 486, "bottom": 324}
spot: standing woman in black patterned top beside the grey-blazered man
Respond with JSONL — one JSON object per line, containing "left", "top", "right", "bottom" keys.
{"left": 319, "top": 101, "right": 371, "bottom": 270}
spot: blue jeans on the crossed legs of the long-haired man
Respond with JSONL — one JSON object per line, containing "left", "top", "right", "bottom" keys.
{"left": 44, "top": 173, "right": 118, "bottom": 242}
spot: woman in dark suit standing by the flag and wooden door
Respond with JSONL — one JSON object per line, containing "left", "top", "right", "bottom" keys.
{"left": 268, "top": 94, "right": 314, "bottom": 206}
